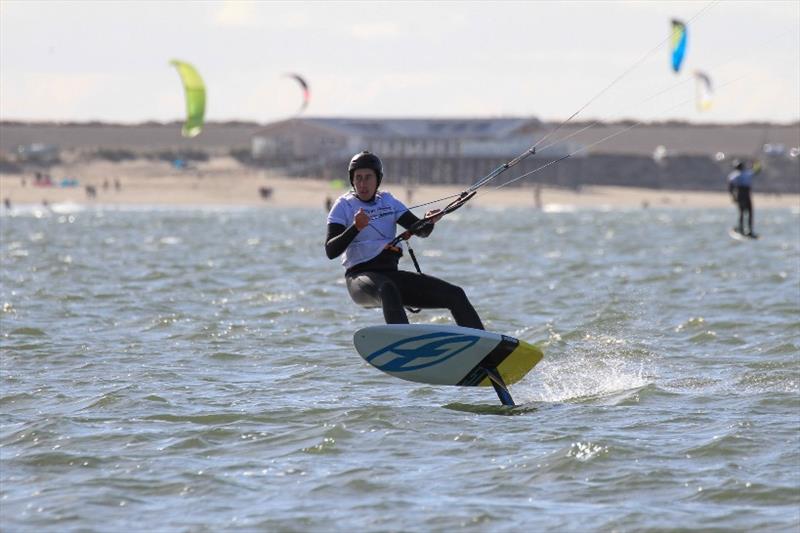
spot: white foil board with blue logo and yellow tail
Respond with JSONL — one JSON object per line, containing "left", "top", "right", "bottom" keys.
{"left": 353, "top": 324, "right": 542, "bottom": 405}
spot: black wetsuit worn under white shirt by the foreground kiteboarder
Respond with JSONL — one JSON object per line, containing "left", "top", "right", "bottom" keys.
{"left": 325, "top": 211, "right": 484, "bottom": 329}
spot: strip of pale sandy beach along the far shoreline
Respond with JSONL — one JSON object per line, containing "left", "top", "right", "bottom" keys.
{"left": 0, "top": 158, "right": 800, "bottom": 209}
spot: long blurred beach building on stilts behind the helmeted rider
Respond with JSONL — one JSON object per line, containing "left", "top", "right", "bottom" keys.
{"left": 251, "top": 118, "right": 582, "bottom": 183}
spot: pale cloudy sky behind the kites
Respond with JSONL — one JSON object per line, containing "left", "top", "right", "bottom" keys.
{"left": 0, "top": 0, "right": 800, "bottom": 123}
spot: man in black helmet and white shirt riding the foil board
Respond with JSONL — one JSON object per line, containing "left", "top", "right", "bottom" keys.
{"left": 325, "top": 151, "right": 484, "bottom": 329}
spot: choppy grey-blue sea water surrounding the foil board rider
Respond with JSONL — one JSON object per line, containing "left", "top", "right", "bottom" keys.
{"left": 0, "top": 202, "right": 800, "bottom": 533}
